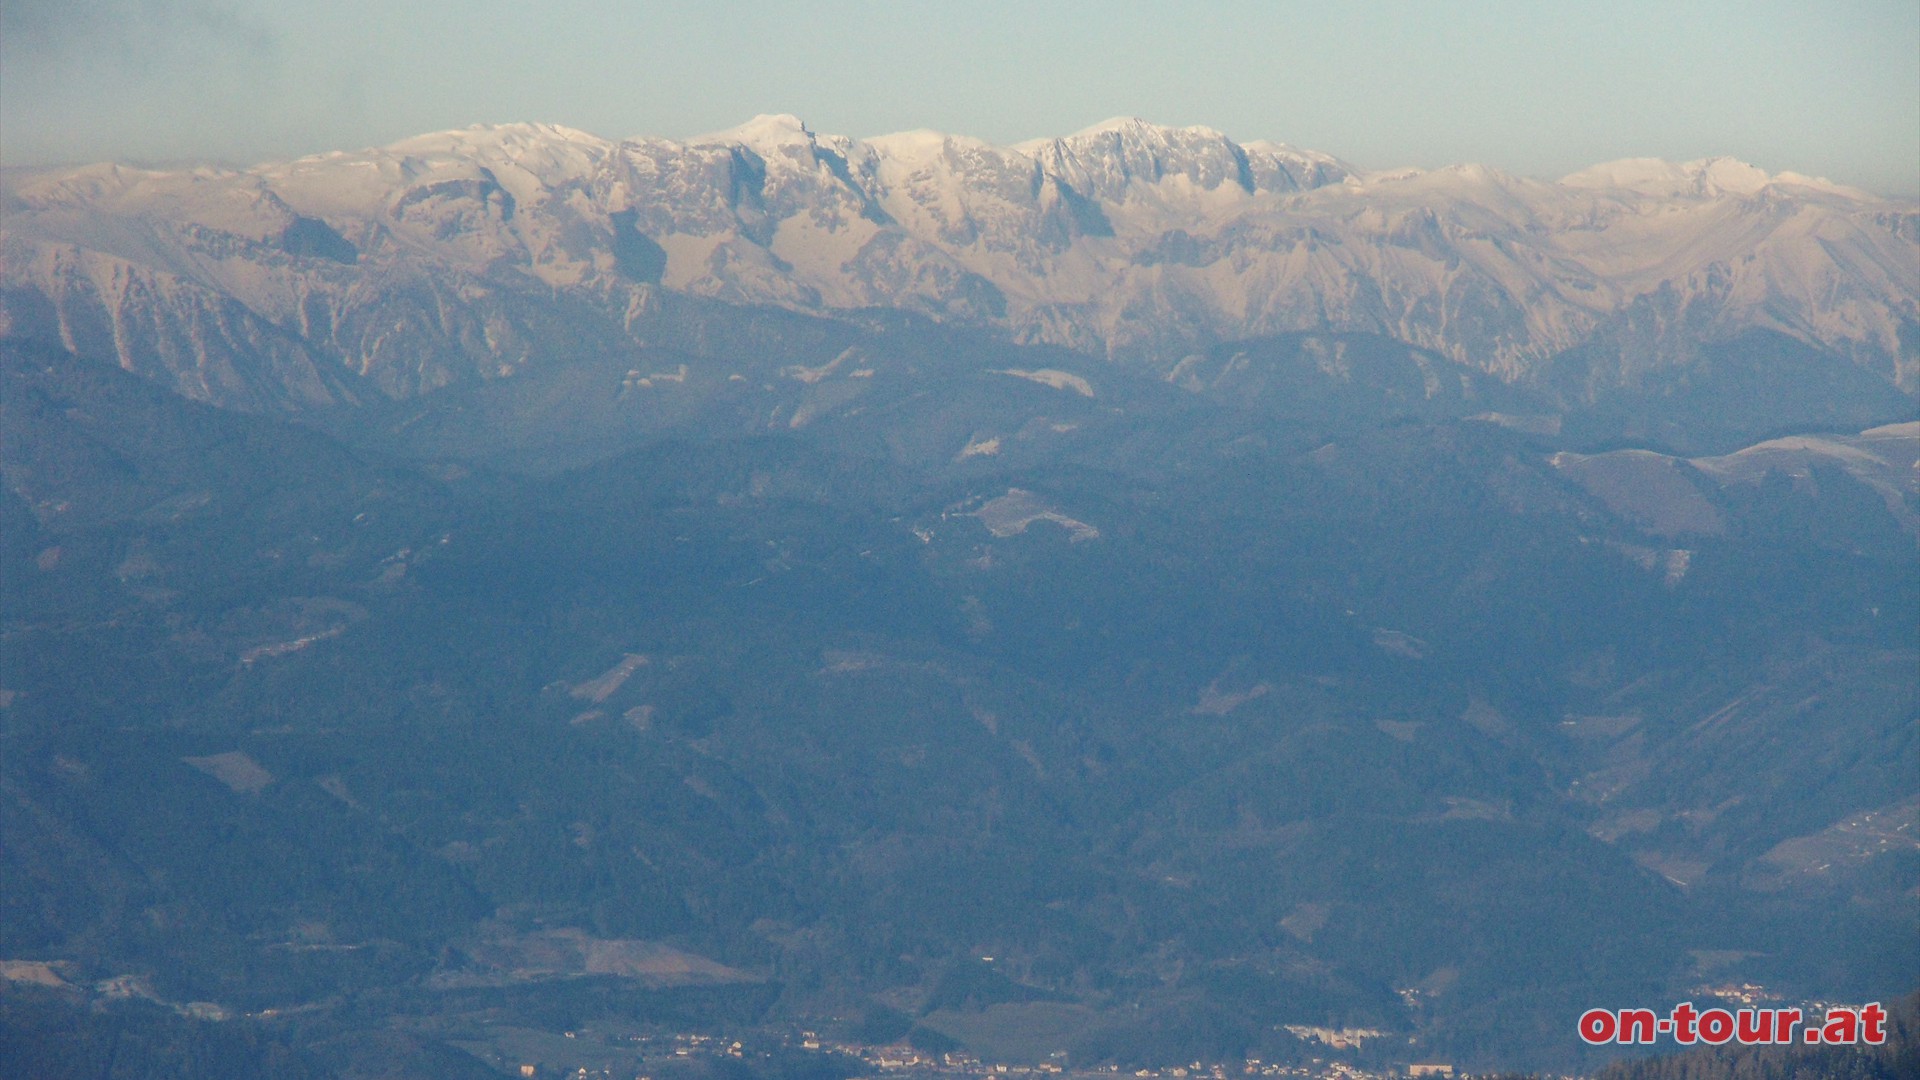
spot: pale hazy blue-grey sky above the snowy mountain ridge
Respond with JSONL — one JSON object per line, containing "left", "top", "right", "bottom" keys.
{"left": 0, "top": 0, "right": 1920, "bottom": 194}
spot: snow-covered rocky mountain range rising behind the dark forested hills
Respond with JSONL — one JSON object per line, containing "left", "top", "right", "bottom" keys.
{"left": 0, "top": 115, "right": 1920, "bottom": 409}
